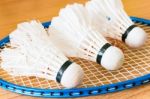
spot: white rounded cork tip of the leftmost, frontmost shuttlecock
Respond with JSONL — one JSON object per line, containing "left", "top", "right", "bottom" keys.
{"left": 61, "top": 63, "right": 84, "bottom": 88}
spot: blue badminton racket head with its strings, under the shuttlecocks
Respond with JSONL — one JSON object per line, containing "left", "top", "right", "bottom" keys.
{"left": 0, "top": 17, "right": 150, "bottom": 98}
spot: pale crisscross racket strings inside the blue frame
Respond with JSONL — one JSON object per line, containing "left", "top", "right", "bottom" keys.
{"left": 0, "top": 23, "right": 150, "bottom": 89}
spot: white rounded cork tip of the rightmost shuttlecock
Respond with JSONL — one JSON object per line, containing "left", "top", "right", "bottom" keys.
{"left": 125, "top": 27, "right": 147, "bottom": 48}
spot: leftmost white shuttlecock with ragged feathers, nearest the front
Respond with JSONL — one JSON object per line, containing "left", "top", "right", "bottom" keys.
{"left": 0, "top": 20, "right": 84, "bottom": 88}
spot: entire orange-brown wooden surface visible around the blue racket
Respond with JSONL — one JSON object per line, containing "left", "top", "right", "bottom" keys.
{"left": 0, "top": 0, "right": 150, "bottom": 99}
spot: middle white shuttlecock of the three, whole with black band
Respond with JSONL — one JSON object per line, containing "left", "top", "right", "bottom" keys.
{"left": 48, "top": 4, "right": 124, "bottom": 70}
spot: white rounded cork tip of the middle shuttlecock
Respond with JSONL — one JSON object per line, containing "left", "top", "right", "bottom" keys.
{"left": 101, "top": 46, "right": 124, "bottom": 70}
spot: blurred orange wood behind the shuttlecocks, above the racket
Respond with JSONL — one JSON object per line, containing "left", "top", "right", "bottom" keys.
{"left": 0, "top": 0, "right": 150, "bottom": 38}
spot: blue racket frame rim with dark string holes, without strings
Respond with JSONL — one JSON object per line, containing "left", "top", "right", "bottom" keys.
{"left": 0, "top": 17, "right": 150, "bottom": 98}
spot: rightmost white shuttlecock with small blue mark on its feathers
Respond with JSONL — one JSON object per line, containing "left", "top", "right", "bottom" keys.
{"left": 86, "top": 0, "right": 147, "bottom": 48}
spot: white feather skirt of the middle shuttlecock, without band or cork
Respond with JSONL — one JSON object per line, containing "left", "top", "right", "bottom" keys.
{"left": 49, "top": 4, "right": 122, "bottom": 69}
